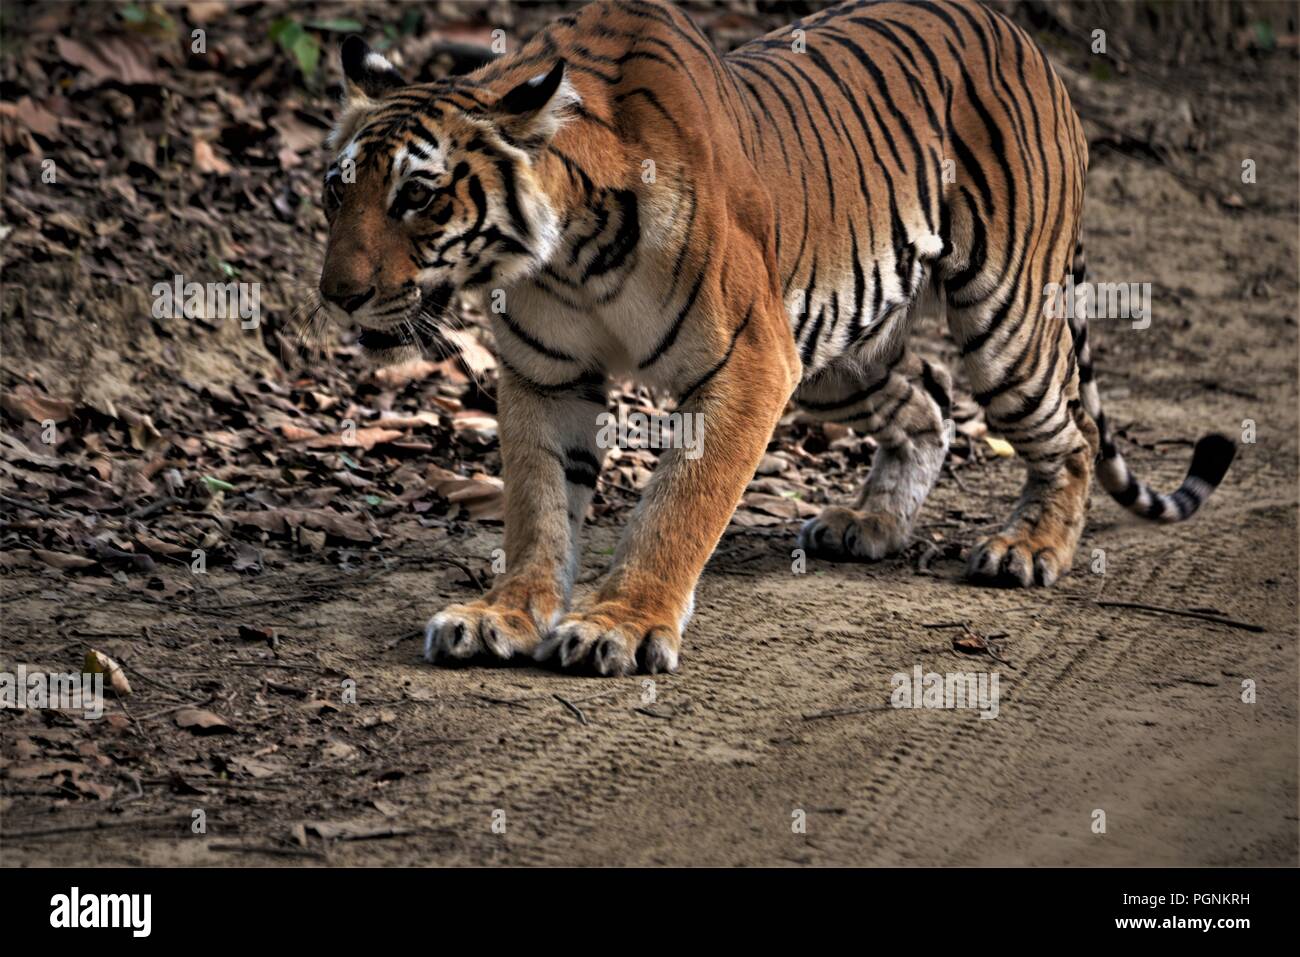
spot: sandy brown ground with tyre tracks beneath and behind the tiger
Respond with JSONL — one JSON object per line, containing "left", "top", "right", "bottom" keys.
{"left": 0, "top": 9, "right": 1297, "bottom": 865}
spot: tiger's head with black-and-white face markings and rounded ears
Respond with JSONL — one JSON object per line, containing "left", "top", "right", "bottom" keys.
{"left": 320, "top": 36, "right": 579, "bottom": 358}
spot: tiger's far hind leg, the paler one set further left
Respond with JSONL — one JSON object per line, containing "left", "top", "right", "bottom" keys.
{"left": 796, "top": 350, "right": 952, "bottom": 560}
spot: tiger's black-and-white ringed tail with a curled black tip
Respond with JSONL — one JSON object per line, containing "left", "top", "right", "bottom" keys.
{"left": 1067, "top": 239, "right": 1236, "bottom": 521}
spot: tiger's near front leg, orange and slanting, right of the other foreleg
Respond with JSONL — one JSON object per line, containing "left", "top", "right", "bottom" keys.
{"left": 536, "top": 295, "right": 800, "bottom": 675}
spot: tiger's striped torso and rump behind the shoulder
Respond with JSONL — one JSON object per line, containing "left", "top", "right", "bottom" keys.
{"left": 727, "top": 3, "right": 1087, "bottom": 373}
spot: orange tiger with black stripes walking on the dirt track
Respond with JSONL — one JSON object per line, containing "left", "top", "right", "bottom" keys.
{"left": 319, "top": 0, "right": 1235, "bottom": 676}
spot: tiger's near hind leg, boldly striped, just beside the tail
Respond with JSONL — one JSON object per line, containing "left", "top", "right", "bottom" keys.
{"left": 949, "top": 280, "right": 1099, "bottom": 588}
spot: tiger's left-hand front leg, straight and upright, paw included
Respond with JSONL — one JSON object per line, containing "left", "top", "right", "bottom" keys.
{"left": 424, "top": 368, "right": 605, "bottom": 662}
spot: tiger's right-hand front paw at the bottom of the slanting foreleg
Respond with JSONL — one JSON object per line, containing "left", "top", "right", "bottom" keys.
{"left": 533, "top": 602, "right": 681, "bottom": 676}
